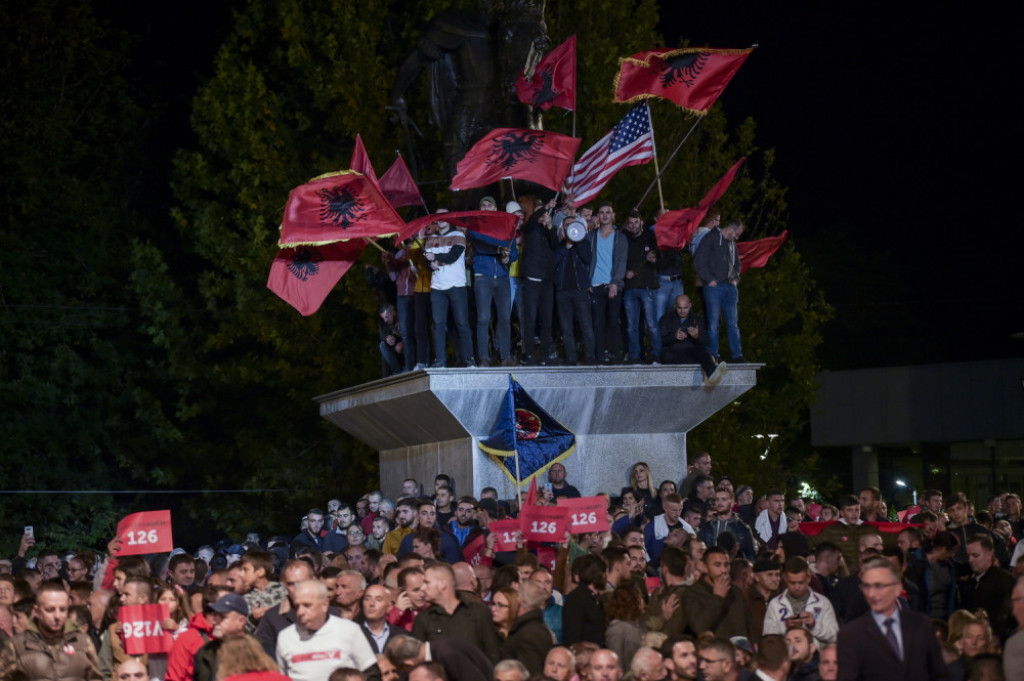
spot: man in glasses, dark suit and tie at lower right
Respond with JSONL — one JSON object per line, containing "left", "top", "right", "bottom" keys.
{"left": 839, "top": 557, "right": 949, "bottom": 681}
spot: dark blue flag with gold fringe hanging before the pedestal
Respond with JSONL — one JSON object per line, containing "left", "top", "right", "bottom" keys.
{"left": 479, "top": 374, "right": 575, "bottom": 482}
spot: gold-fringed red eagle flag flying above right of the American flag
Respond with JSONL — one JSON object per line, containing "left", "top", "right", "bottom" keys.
{"left": 614, "top": 47, "right": 754, "bottom": 116}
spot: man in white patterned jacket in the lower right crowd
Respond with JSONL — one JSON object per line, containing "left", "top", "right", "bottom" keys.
{"left": 764, "top": 556, "right": 839, "bottom": 648}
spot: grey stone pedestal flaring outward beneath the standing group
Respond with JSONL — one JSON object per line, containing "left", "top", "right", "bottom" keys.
{"left": 316, "top": 365, "right": 763, "bottom": 499}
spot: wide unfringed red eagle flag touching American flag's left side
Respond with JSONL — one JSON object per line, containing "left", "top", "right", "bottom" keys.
{"left": 452, "top": 128, "right": 580, "bottom": 191}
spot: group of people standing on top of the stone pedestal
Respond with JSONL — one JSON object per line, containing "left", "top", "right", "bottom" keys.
{"left": 368, "top": 197, "right": 745, "bottom": 382}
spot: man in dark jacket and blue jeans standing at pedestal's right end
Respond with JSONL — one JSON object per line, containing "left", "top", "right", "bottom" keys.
{"left": 693, "top": 219, "right": 746, "bottom": 364}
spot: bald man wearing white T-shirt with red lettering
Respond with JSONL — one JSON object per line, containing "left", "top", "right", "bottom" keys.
{"left": 276, "top": 580, "right": 379, "bottom": 681}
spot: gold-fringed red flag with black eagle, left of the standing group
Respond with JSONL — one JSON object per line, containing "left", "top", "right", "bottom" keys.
{"left": 278, "top": 170, "right": 406, "bottom": 248}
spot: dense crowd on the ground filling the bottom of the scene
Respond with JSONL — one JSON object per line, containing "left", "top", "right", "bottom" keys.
{"left": 0, "top": 454, "right": 1024, "bottom": 681}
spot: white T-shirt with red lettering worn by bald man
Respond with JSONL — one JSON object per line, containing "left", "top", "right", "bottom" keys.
{"left": 278, "top": 614, "right": 377, "bottom": 681}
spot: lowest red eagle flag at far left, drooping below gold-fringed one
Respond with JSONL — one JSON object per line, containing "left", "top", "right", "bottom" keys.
{"left": 266, "top": 240, "right": 367, "bottom": 316}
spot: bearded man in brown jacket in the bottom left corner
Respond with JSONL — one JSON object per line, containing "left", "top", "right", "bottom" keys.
{"left": 0, "top": 582, "right": 102, "bottom": 681}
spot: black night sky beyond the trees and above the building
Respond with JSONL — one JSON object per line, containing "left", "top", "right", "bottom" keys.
{"left": 119, "top": 0, "right": 1024, "bottom": 368}
